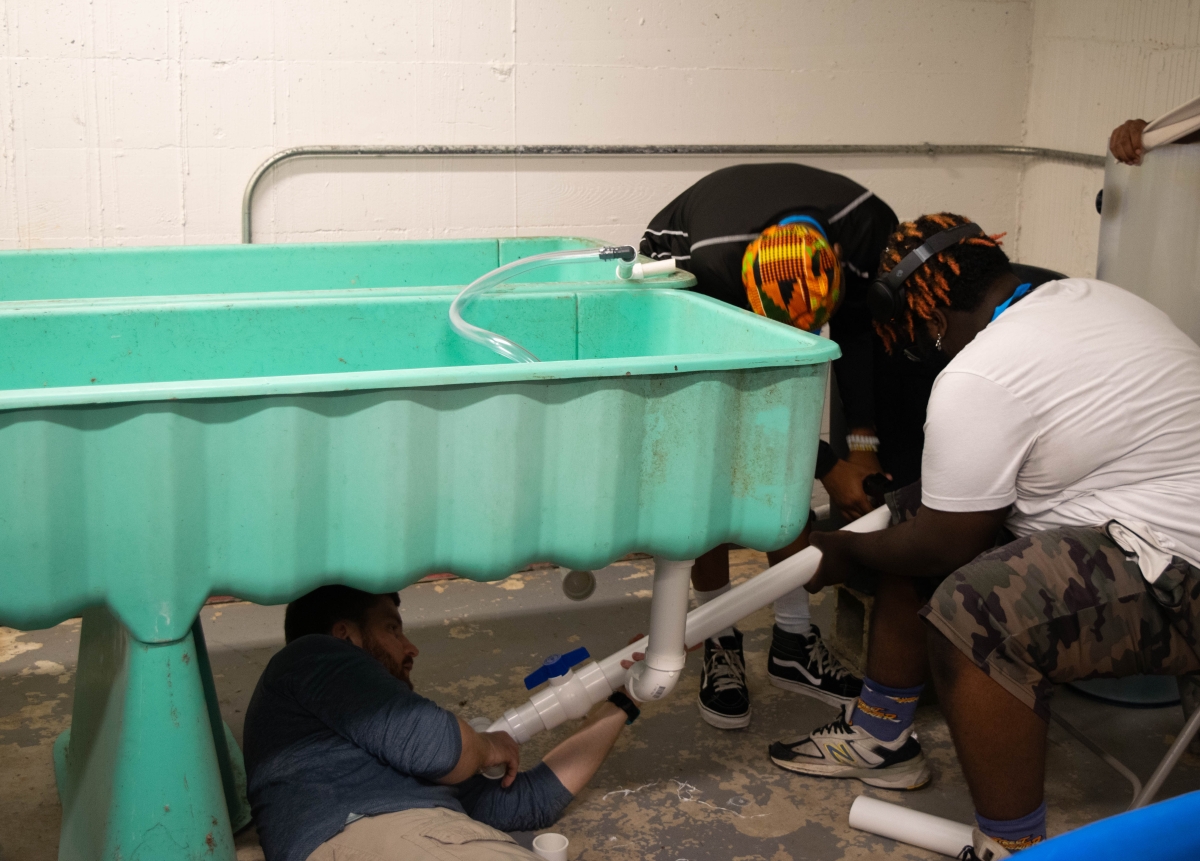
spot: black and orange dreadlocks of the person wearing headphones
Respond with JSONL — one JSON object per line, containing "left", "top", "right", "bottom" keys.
{"left": 875, "top": 212, "right": 1010, "bottom": 353}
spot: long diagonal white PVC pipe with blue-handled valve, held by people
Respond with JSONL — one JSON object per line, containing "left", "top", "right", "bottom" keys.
{"left": 490, "top": 506, "right": 890, "bottom": 745}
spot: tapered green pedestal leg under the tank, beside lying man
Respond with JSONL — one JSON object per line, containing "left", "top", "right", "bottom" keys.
{"left": 54, "top": 608, "right": 250, "bottom": 861}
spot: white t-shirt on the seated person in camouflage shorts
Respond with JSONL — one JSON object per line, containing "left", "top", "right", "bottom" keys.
{"left": 922, "top": 278, "right": 1200, "bottom": 565}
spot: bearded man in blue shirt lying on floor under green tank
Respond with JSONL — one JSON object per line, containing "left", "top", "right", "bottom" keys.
{"left": 245, "top": 586, "right": 637, "bottom": 861}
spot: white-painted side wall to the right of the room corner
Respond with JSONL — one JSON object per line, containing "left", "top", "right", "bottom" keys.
{"left": 1016, "top": 0, "right": 1200, "bottom": 276}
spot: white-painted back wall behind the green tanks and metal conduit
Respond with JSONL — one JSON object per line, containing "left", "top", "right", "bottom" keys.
{"left": 0, "top": 0, "right": 1033, "bottom": 247}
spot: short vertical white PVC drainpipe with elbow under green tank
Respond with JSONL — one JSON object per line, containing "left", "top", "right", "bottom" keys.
{"left": 625, "top": 556, "right": 692, "bottom": 703}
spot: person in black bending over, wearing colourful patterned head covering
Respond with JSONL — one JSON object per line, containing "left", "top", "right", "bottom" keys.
{"left": 641, "top": 163, "right": 912, "bottom": 729}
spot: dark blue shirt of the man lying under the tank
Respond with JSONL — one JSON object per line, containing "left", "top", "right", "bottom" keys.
{"left": 244, "top": 634, "right": 572, "bottom": 861}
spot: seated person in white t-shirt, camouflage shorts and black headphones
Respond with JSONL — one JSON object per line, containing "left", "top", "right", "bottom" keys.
{"left": 770, "top": 215, "right": 1200, "bottom": 857}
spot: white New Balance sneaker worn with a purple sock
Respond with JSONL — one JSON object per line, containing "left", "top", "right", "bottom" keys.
{"left": 770, "top": 712, "right": 929, "bottom": 789}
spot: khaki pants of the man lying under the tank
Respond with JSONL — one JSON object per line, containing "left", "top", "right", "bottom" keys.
{"left": 308, "top": 807, "right": 538, "bottom": 861}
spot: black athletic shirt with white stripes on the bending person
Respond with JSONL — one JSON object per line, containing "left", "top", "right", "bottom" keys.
{"left": 641, "top": 163, "right": 896, "bottom": 458}
